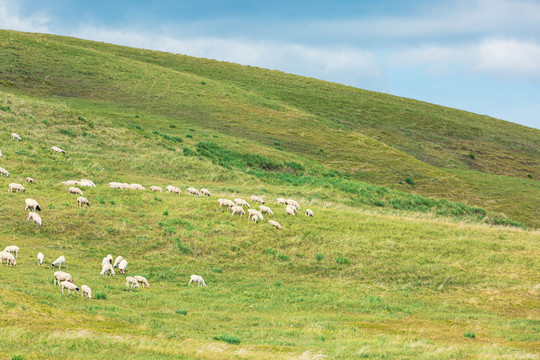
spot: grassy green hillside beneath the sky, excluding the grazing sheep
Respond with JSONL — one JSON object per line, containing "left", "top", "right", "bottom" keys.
{"left": 0, "top": 31, "right": 540, "bottom": 359}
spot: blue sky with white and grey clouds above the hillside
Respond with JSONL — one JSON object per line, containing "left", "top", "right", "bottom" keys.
{"left": 0, "top": 0, "right": 540, "bottom": 128}
